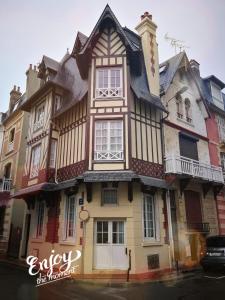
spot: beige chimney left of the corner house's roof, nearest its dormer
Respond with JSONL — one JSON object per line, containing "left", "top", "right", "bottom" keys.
{"left": 26, "top": 64, "right": 41, "bottom": 98}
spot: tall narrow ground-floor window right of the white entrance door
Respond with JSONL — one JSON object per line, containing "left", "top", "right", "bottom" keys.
{"left": 143, "top": 194, "right": 156, "bottom": 239}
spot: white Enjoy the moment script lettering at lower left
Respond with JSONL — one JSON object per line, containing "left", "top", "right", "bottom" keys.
{"left": 26, "top": 250, "right": 81, "bottom": 286}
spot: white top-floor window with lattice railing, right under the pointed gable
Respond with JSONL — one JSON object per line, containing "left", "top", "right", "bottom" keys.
{"left": 95, "top": 68, "right": 123, "bottom": 98}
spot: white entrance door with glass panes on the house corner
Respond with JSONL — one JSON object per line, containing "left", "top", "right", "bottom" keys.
{"left": 94, "top": 220, "right": 128, "bottom": 270}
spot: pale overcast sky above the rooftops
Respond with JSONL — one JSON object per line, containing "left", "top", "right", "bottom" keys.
{"left": 0, "top": 0, "right": 225, "bottom": 111}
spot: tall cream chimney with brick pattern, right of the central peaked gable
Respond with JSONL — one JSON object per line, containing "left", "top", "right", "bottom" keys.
{"left": 135, "top": 12, "right": 159, "bottom": 96}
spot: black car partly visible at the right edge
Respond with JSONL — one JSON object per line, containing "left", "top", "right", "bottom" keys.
{"left": 200, "top": 235, "right": 225, "bottom": 270}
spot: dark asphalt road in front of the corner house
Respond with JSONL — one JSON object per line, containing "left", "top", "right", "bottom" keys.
{"left": 0, "top": 264, "right": 225, "bottom": 300}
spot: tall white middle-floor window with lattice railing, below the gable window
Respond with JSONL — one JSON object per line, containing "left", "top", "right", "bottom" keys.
{"left": 95, "top": 120, "right": 123, "bottom": 160}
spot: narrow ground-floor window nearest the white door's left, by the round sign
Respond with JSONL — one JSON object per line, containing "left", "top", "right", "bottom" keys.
{"left": 64, "top": 195, "right": 76, "bottom": 240}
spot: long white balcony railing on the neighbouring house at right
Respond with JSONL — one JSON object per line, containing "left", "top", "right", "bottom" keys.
{"left": 165, "top": 155, "right": 224, "bottom": 183}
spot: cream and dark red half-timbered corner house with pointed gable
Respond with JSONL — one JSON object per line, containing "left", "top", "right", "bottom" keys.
{"left": 15, "top": 5, "right": 176, "bottom": 277}
